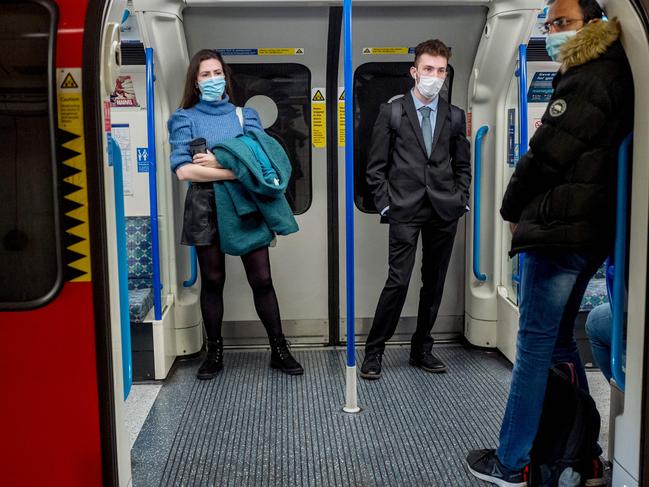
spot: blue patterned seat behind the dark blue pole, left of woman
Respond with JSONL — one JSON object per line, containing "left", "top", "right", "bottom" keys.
{"left": 126, "top": 216, "right": 153, "bottom": 323}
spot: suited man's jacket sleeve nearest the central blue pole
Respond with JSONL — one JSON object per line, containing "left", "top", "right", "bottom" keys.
{"left": 365, "top": 103, "right": 390, "bottom": 212}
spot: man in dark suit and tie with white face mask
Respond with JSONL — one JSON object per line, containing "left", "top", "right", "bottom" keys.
{"left": 360, "top": 39, "right": 471, "bottom": 379}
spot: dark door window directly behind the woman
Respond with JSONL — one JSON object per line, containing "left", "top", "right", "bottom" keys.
{"left": 230, "top": 63, "right": 311, "bottom": 215}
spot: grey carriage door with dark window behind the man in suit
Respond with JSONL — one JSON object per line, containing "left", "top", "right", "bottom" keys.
{"left": 339, "top": 5, "right": 488, "bottom": 346}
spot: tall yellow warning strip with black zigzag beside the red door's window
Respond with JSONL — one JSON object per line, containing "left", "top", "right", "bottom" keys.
{"left": 57, "top": 68, "right": 91, "bottom": 282}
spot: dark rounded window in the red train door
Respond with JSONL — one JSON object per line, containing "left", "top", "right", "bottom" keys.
{"left": 0, "top": 2, "right": 62, "bottom": 309}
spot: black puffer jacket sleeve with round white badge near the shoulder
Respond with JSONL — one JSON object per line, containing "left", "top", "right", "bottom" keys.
{"left": 500, "top": 77, "right": 612, "bottom": 223}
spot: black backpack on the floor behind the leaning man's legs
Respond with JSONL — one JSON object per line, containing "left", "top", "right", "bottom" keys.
{"left": 528, "top": 363, "right": 600, "bottom": 487}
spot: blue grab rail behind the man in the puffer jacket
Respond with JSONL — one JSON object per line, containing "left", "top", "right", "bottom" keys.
{"left": 611, "top": 134, "right": 633, "bottom": 391}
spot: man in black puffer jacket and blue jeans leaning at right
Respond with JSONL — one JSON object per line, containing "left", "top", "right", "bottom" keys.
{"left": 467, "top": 0, "right": 633, "bottom": 486}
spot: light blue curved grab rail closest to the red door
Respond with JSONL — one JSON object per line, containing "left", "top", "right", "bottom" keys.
{"left": 108, "top": 135, "right": 133, "bottom": 400}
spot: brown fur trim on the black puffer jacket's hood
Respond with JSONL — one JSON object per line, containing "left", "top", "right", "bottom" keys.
{"left": 560, "top": 18, "right": 621, "bottom": 73}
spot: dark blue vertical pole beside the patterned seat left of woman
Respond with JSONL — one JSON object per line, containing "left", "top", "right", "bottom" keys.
{"left": 145, "top": 47, "right": 162, "bottom": 321}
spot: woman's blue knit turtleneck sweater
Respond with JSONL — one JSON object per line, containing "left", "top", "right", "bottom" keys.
{"left": 167, "top": 96, "right": 263, "bottom": 172}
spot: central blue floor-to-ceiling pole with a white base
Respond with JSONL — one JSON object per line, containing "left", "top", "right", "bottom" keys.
{"left": 344, "top": 0, "right": 360, "bottom": 413}
